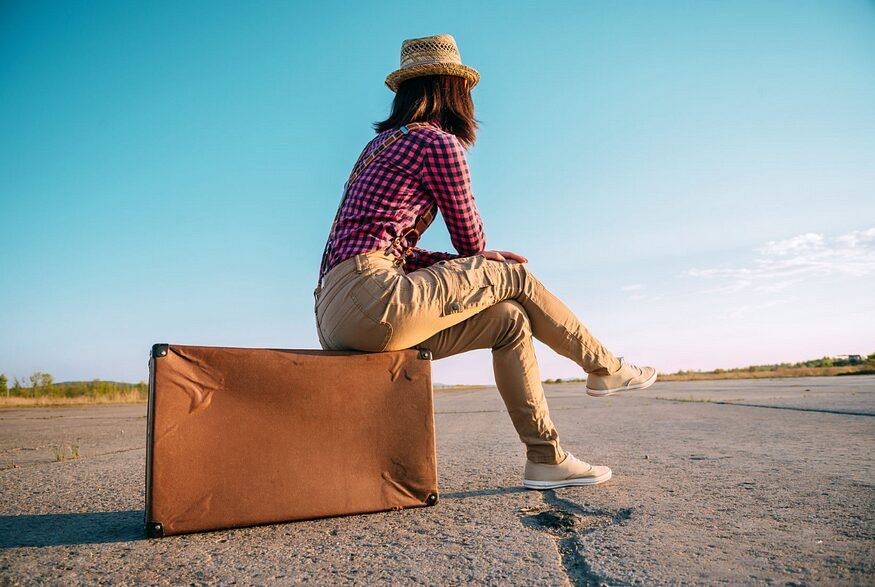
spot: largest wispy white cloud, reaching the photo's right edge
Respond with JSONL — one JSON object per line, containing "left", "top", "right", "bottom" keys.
{"left": 687, "top": 228, "right": 875, "bottom": 293}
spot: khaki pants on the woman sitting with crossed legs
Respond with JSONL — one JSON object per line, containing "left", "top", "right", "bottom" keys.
{"left": 316, "top": 252, "right": 619, "bottom": 463}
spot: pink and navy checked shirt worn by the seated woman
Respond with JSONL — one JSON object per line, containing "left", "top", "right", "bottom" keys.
{"left": 326, "top": 122, "right": 486, "bottom": 272}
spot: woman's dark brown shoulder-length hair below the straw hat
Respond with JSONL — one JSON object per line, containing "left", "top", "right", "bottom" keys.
{"left": 374, "top": 75, "right": 477, "bottom": 149}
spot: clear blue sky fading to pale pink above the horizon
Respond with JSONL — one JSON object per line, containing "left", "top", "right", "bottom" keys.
{"left": 0, "top": 1, "right": 875, "bottom": 383}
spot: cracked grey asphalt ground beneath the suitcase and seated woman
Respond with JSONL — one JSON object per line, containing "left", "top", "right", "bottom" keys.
{"left": 0, "top": 376, "right": 875, "bottom": 585}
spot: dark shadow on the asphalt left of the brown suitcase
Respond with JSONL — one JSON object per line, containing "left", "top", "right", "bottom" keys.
{"left": 0, "top": 510, "right": 146, "bottom": 548}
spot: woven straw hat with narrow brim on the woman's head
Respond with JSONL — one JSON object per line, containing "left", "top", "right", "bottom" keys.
{"left": 386, "top": 35, "right": 480, "bottom": 92}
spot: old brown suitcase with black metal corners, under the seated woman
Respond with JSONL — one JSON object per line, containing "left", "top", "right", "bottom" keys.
{"left": 146, "top": 344, "right": 438, "bottom": 537}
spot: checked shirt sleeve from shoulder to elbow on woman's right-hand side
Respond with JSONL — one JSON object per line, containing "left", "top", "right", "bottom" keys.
{"left": 422, "top": 133, "right": 486, "bottom": 258}
